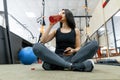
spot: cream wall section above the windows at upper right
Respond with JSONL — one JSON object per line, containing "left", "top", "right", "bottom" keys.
{"left": 89, "top": 0, "right": 120, "bottom": 35}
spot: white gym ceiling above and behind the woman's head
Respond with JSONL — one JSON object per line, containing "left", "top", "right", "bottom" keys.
{"left": 0, "top": 0, "right": 99, "bottom": 39}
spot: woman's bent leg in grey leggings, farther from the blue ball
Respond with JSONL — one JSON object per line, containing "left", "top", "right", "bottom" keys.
{"left": 71, "top": 41, "right": 98, "bottom": 64}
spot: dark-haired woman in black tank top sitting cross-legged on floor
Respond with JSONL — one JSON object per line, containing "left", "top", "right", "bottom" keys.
{"left": 33, "top": 9, "right": 98, "bottom": 72}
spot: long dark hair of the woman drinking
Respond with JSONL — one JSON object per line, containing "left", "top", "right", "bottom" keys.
{"left": 60, "top": 9, "right": 75, "bottom": 29}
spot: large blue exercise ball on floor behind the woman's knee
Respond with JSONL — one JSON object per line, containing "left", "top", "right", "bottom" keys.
{"left": 18, "top": 47, "right": 37, "bottom": 65}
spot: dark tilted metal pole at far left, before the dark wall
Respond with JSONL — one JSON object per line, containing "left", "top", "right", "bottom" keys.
{"left": 3, "top": 0, "right": 13, "bottom": 64}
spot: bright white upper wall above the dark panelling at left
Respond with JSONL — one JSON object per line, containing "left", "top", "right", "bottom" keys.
{"left": 0, "top": 0, "right": 37, "bottom": 43}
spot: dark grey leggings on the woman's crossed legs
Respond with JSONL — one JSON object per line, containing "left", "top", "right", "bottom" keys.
{"left": 33, "top": 41, "right": 98, "bottom": 69}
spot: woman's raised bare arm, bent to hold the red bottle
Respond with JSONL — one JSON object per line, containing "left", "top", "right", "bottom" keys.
{"left": 40, "top": 23, "right": 56, "bottom": 44}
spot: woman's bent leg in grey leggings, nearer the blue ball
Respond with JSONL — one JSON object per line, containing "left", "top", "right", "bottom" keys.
{"left": 33, "top": 43, "right": 72, "bottom": 68}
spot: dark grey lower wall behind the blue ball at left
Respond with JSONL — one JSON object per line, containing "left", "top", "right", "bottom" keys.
{"left": 0, "top": 26, "right": 32, "bottom": 64}
